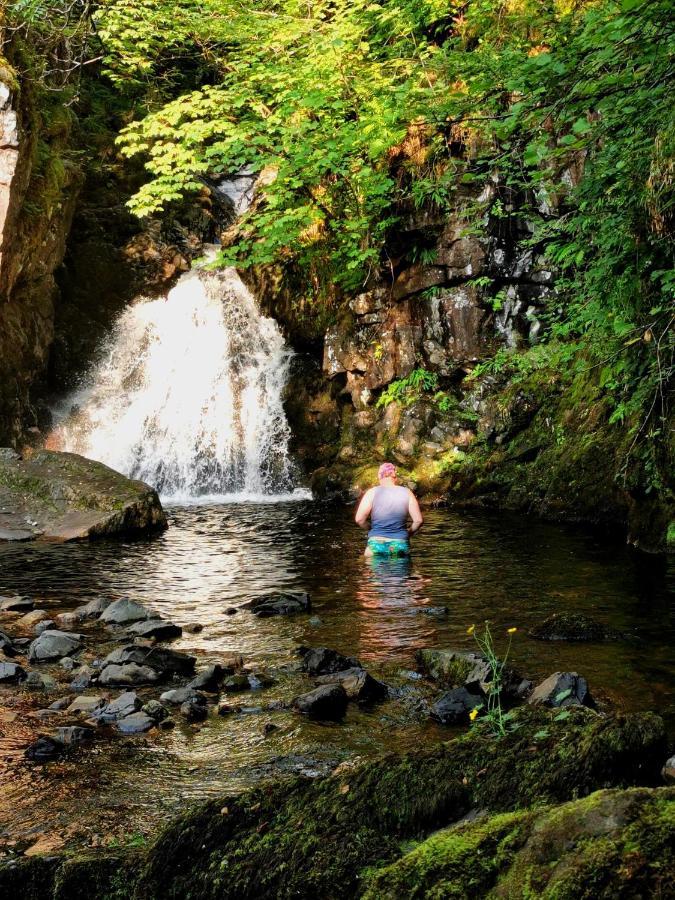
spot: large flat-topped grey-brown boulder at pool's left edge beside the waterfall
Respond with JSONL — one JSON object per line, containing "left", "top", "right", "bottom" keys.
{"left": 0, "top": 450, "right": 166, "bottom": 541}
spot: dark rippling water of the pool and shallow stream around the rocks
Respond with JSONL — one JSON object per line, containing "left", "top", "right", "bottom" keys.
{"left": 0, "top": 506, "right": 675, "bottom": 843}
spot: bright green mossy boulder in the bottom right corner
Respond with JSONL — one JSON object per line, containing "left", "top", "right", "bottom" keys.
{"left": 364, "top": 788, "right": 675, "bottom": 900}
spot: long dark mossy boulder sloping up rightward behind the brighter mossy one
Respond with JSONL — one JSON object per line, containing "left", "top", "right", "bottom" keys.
{"left": 137, "top": 709, "right": 665, "bottom": 900}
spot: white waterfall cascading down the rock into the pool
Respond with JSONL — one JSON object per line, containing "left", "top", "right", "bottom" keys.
{"left": 51, "top": 269, "right": 308, "bottom": 502}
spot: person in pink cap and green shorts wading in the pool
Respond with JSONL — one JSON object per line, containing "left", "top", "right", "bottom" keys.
{"left": 354, "top": 463, "right": 424, "bottom": 556}
